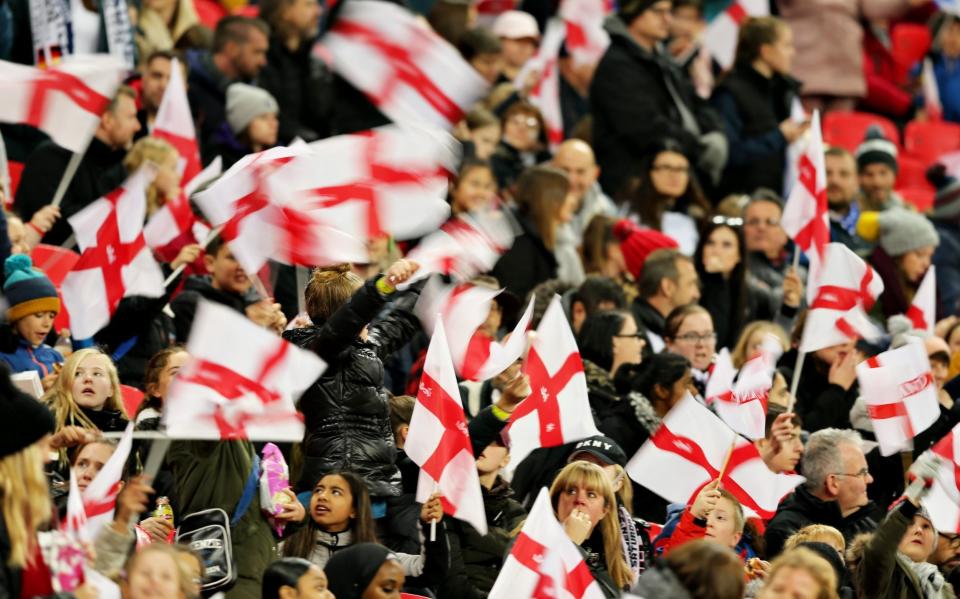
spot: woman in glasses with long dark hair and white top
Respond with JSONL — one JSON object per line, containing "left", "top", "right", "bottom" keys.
{"left": 626, "top": 139, "right": 711, "bottom": 256}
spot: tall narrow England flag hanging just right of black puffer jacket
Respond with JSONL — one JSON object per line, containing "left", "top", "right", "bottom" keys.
{"left": 404, "top": 320, "right": 487, "bottom": 535}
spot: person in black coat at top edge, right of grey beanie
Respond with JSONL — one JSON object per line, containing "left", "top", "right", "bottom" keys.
{"left": 256, "top": 0, "right": 333, "bottom": 144}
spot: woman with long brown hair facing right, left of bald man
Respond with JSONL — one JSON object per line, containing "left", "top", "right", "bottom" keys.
{"left": 491, "top": 166, "right": 573, "bottom": 298}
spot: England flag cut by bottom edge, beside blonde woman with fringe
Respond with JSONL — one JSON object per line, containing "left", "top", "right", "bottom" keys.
{"left": 488, "top": 488, "right": 604, "bottom": 599}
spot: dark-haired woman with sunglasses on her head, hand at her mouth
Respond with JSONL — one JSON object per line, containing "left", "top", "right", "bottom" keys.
{"left": 694, "top": 217, "right": 803, "bottom": 348}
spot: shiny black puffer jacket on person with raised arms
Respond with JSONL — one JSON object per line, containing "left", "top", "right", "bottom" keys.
{"left": 283, "top": 279, "right": 422, "bottom": 497}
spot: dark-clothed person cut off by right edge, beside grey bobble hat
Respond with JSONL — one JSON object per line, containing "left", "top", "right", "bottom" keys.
{"left": 927, "top": 164, "right": 960, "bottom": 316}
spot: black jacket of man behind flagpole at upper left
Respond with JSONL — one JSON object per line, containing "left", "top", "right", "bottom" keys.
{"left": 13, "top": 137, "right": 127, "bottom": 245}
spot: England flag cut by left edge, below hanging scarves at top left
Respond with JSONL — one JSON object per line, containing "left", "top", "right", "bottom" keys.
{"left": 0, "top": 54, "right": 127, "bottom": 152}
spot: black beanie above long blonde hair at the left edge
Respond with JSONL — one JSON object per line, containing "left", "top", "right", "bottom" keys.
{"left": 0, "top": 363, "right": 56, "bottom": 458}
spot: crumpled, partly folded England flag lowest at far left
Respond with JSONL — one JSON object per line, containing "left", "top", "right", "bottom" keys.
{"left": 63, "top": 422, "right": 133, "bottom": 543}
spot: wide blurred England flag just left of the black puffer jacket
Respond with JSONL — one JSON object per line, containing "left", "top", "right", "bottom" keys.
{"left": 163, "top": 301, "right": 326, "bottom": 441}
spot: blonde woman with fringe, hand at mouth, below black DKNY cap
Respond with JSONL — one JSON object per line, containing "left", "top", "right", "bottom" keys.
{"left": 550, "top": 461, "right": 634, "bottom": 597}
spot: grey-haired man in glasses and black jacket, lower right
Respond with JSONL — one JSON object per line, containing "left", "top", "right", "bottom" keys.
{"left": 765, "top": 428, "right": 877, "bottom": 556}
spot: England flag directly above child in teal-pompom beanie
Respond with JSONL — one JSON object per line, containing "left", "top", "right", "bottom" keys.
{"left": 61, "top": 168, "right": 166, "bottom": 339}
